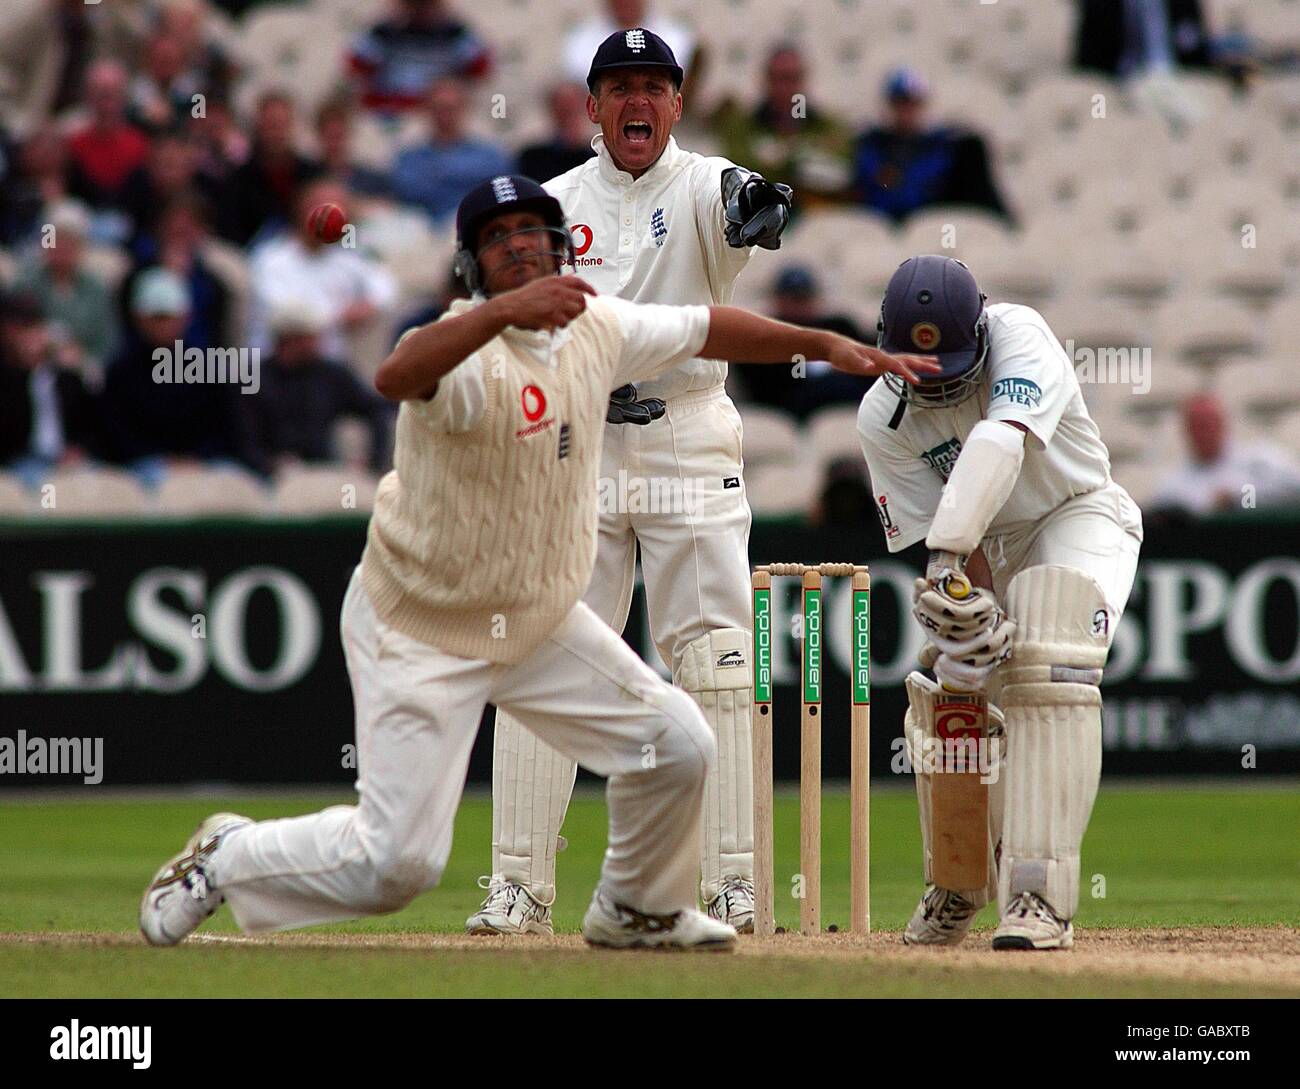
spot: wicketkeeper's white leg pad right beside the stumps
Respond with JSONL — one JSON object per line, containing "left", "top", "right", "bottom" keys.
{"left": 673, "top": 628, "right": 754, "bottom": 903}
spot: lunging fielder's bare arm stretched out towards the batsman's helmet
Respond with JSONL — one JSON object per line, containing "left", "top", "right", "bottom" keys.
{"left": 699, "top": 307, "right": 940, "bottom": 383}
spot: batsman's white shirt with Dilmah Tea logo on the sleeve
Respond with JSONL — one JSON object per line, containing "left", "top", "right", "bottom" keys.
{"left": 858, "top": 303, "right": 1110, "bottom": 552}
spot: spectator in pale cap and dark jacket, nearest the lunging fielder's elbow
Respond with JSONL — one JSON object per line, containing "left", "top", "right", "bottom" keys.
{"left": 243, "top": 298, "right": 393, "bottom": 476}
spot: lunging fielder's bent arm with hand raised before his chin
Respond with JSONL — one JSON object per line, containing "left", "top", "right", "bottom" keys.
{"left": 374, "top": 275, "right": 595, "bottom": 400}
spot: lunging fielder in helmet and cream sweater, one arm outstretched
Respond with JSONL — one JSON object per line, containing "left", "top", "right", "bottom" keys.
{"left": 139, "top": 175, "right": 933, "bottom": 950}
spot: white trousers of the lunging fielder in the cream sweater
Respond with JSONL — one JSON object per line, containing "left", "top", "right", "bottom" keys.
{"left": 212, "top": 569, "right": 715, "bottom": 932}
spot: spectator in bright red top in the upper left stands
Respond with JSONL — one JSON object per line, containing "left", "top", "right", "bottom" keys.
{"left": 68, "top": 61, "right": 150, "bottom": 222}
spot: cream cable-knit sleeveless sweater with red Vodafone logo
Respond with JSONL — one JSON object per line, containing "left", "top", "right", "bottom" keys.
{"left": 361, "top": 303, "right": 623, "bottom": 663}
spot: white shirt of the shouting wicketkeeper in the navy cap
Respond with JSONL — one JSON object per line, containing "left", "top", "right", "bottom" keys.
{"left": 543, "top": 135, "right": 754, "bottom": 398}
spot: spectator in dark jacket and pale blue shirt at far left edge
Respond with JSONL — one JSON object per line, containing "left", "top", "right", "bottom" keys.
{"left": 0, "top": 292, "right": 96, "bottom": 487}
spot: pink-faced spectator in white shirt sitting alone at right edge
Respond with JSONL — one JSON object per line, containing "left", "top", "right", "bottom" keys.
{"left": 1147, "top": 394, "right": 1300, "bottom": 516}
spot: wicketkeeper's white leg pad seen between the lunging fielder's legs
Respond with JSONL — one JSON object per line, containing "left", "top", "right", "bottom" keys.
{"left": 491, "top": 711, "right": 577, "bottom": 904}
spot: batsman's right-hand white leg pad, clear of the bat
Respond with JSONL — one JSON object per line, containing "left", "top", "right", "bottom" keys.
{"left": 998, "top": 565, "right": 1108, "bottom": 919}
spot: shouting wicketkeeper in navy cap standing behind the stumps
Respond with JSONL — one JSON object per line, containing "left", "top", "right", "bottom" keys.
{"left": 465, "top": 27, "right": 790, "bottom": 934}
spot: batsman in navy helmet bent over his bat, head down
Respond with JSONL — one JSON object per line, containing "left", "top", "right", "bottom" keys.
{"left": 858, "top": 256, "right": 1143, "bottom": 950}
